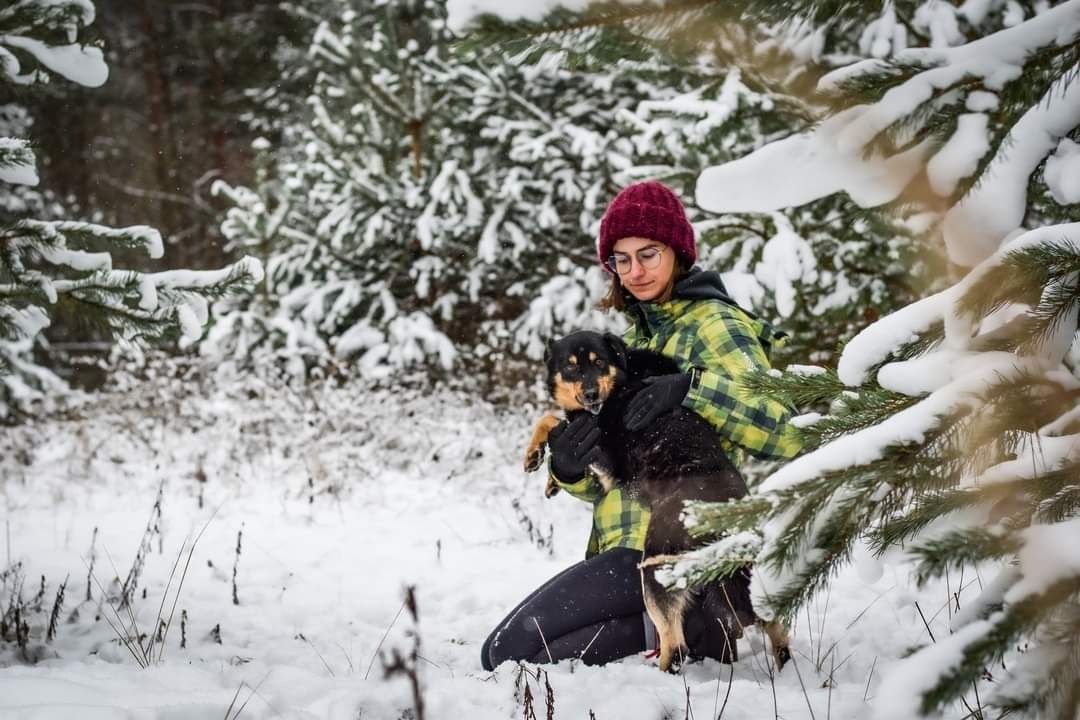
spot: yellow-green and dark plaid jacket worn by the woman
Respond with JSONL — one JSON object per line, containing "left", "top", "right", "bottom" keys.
{"left": 554, "top": 287, "right": 800, "bottom": 557}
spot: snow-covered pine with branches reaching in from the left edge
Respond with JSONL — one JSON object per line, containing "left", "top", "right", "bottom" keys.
{"left": 0, "top": 0, "right": 261, "bottom": 419}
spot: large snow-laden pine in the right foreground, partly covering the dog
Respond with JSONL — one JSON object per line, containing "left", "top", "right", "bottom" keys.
{"left": 626, "top": 0, "right": 1080, "bottom": 718}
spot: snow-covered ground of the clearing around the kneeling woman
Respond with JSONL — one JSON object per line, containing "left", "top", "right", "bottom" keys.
{"left": 0, "top": 371, "right": 970, "bottom": 720}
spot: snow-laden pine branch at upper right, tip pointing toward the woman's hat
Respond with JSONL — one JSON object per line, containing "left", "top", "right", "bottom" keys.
{"left": 698, "top": 0, "right": 1080, "bottom": 267}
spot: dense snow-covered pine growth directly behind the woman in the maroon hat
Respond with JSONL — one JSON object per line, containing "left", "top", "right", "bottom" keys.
{"left": 206, "top": 2, "right": 937, "bottom": 386}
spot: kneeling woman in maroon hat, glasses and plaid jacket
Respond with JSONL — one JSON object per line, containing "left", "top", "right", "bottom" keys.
{"left": 481, "top": 182, "right": 799, "bottom": 670}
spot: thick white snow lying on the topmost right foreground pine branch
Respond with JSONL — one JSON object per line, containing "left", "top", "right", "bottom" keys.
{"left": 697, "top": 0, "right": 1080, "bottom": 267}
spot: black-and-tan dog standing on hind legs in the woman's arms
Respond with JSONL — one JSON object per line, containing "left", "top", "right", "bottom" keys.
{"left": 525, "top": 331, "right": 791, "bottom": 671}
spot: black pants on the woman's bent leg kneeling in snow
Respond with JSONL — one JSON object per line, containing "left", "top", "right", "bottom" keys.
{"left": 481, "top": 547, "right": 645, "bottom": 670}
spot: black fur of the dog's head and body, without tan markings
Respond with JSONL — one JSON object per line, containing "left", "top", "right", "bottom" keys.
{"left": 544, "top": 331, "right": 755, "bottom": 662}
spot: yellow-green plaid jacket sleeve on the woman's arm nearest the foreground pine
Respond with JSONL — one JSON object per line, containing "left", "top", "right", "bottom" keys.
{"left": 683, "top": 313, "right": 801, "bottom": 459}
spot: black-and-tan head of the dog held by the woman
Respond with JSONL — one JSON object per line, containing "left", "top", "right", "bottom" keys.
{"left": 544, "top": 331, "right": 626, "bottom": 415}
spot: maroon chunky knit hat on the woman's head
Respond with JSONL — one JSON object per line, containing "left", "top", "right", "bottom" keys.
{"left": 596, "top": 180, "right": 698, "bottom": 272}
